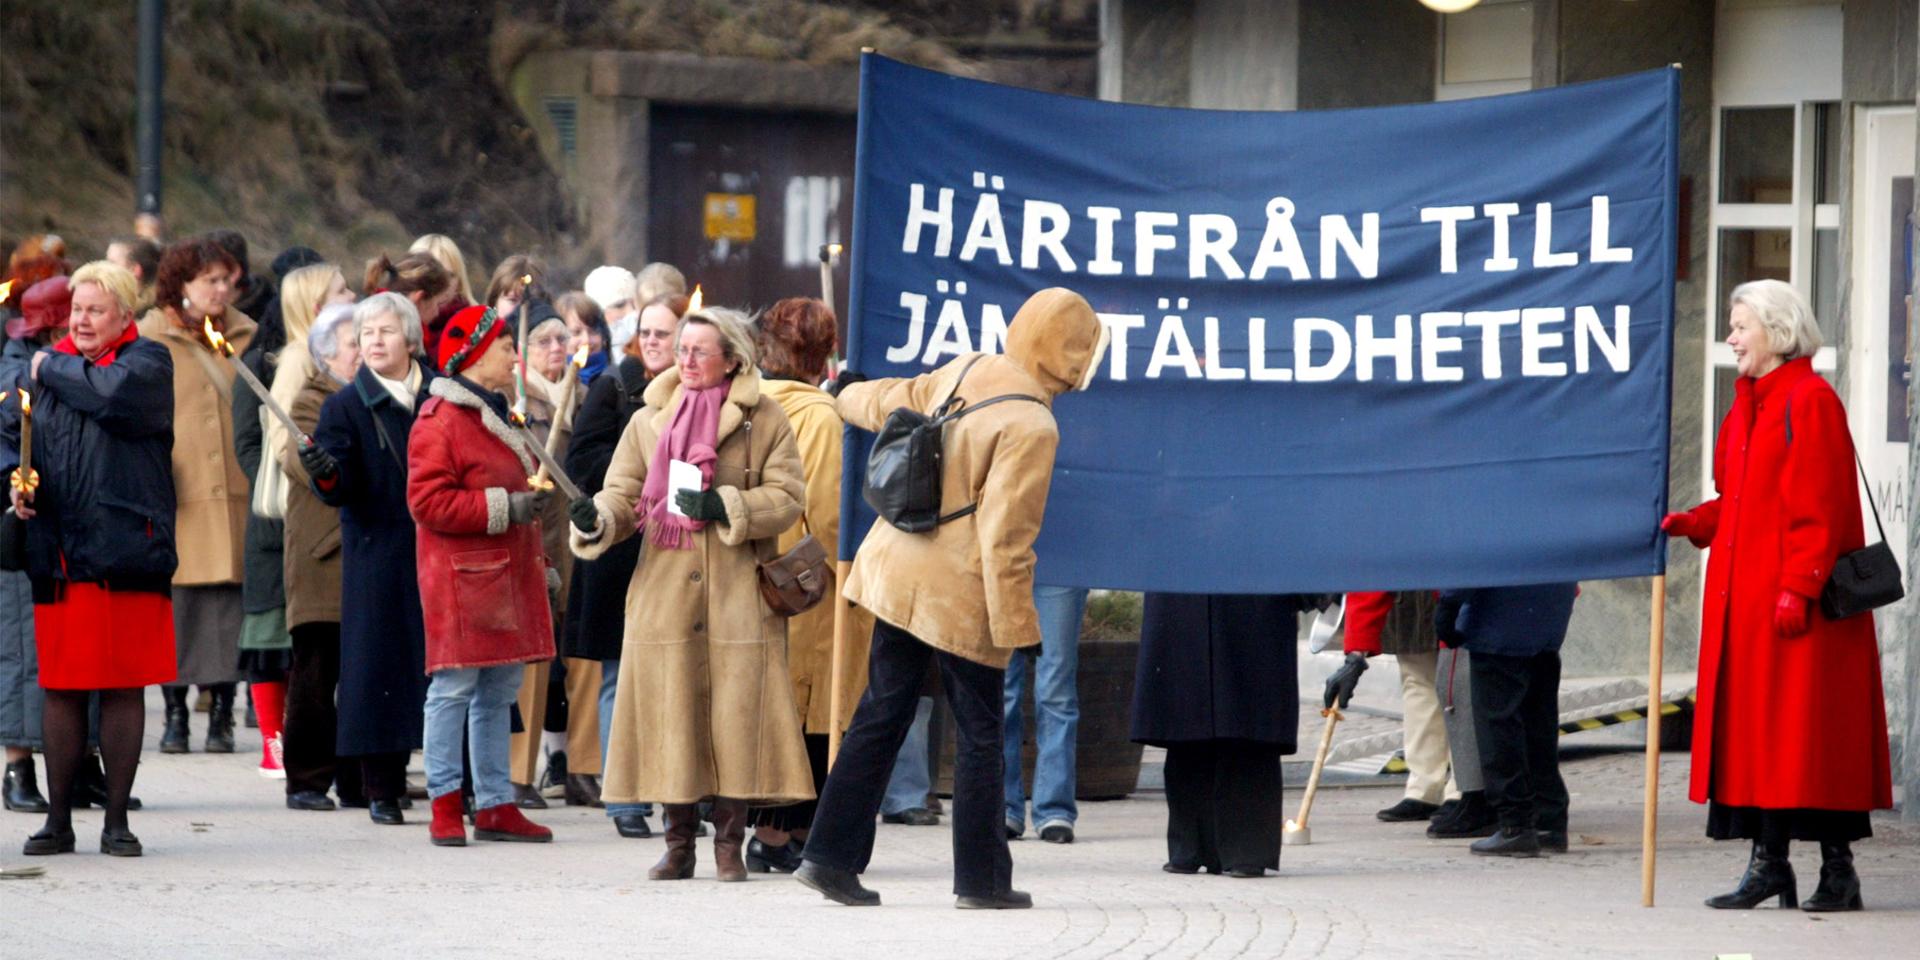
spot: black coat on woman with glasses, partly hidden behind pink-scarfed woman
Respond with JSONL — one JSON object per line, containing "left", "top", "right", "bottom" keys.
{"left": 561, "top": 357, "right": 647, "bottom": 660}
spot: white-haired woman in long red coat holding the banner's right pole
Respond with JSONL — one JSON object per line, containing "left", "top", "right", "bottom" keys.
{"left": 1661, "top": 280, "right": 1893, "bottom": 910}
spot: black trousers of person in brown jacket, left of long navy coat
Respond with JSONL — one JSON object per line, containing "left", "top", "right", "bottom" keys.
{"left": 280, "top": 622, "right": 365, "bottom": 804}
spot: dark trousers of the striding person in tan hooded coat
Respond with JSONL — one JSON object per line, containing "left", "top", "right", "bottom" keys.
{"left": 803, "top": 620, "right": 1014, "bottom": 897}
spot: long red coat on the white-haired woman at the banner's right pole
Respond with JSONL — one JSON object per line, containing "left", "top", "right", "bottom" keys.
{"left": 1690, "top": 359, "right": 1893, "bottom": 810}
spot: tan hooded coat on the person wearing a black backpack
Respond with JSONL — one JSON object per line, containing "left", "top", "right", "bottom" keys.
{"left": 837, "top": 288, "right": 1100, "bottom": 668}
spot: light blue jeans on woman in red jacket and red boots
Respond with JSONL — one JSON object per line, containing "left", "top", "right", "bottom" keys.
{"left": 424, "top": 662, "right": 524, "bottom": 810}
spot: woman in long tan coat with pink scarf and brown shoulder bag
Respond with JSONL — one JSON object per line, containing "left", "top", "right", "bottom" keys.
{"left": 570, "top": 309, "right": 814, "bottom": 881}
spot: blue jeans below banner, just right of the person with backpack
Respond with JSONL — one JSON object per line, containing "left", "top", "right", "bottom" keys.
{"left": 1004, "top": 586, "right": 1087, "bottom": 828}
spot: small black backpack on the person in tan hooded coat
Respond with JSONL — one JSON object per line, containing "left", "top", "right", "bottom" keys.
{"left": 866, "top": 355, "right": 1041, "bottom": 534}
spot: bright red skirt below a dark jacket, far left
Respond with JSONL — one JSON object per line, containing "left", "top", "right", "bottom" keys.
{"left": 33, "top": 584, "right": 179, "bottom": 689}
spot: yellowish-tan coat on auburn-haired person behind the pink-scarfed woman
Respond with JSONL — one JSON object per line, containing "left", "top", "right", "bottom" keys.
{"left": 760, "top": 380, "right": 874, "bottom": 733}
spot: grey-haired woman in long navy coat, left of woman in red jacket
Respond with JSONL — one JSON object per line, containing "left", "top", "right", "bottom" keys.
{"left": 301, "top": 294, "right": 434, "bottom": 824}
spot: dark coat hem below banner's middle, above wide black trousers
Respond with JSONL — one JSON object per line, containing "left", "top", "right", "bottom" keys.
{"left": 1133, "top": 593, "right": 1311, "bottom": 753}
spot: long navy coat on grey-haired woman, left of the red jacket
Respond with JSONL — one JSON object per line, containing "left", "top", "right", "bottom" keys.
{"left": 313, "top": 359, "right": 434, "bottom": 756}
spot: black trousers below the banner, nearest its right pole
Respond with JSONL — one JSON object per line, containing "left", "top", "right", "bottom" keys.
{"left": 1467, "top": 651, "right": 1567, "bottom": 831}
